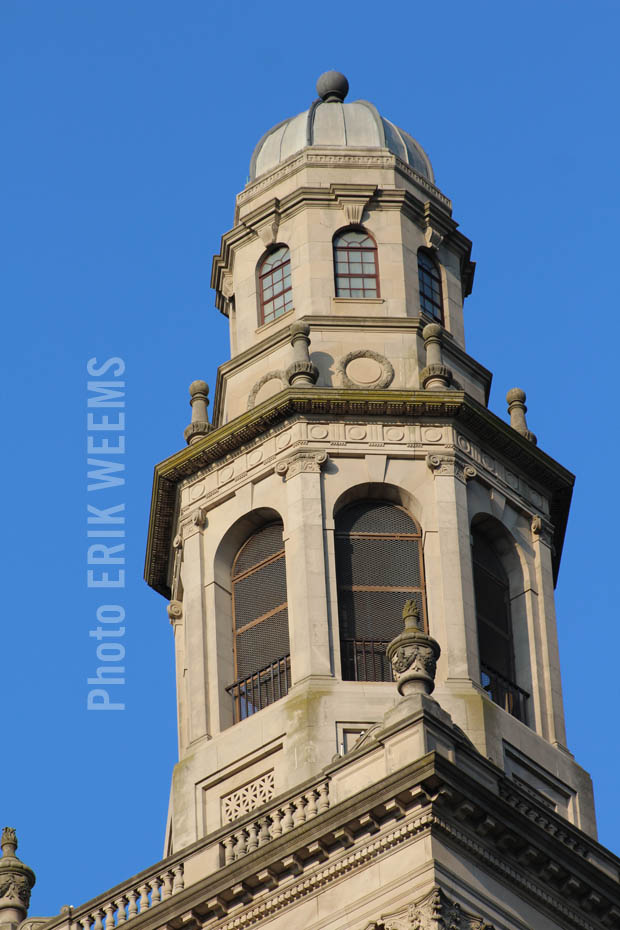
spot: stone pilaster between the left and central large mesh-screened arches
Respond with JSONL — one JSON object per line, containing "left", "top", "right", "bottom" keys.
{"left": 276, "top": 452, "right": 333, "bottom": 684}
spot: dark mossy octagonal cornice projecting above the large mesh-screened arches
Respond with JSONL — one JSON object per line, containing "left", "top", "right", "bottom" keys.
{"left": 144, "top": 387, "right": 574, "bottom": 597}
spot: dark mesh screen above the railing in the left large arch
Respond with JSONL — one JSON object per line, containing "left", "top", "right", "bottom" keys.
{"left": 232, "top": 523, "right": 290, "bottom": 679}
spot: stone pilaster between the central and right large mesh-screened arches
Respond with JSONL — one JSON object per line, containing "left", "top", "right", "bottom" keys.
{"left": 426, "top": 451, "right": 480, "bottom": 683}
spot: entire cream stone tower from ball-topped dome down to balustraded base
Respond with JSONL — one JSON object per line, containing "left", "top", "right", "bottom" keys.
{"left": 29, "top": 72, "right": 620, "bottom": 930}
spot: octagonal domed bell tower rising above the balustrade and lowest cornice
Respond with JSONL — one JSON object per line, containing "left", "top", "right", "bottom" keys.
{"left": 146, "top": 72, "right": 596, "bottom": 864}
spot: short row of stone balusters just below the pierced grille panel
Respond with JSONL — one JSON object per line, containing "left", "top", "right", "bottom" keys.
{"left": 221, "top": 781, "right": 329, "bottom": 865}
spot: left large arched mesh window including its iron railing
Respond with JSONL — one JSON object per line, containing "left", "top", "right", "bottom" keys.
{"left": 226, "top": 521, "right": 290, "bottom": 722}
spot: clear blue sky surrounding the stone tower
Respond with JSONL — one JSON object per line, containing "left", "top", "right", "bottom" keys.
{"left": 0, "top": 0, "right": 620, "bottom": 915}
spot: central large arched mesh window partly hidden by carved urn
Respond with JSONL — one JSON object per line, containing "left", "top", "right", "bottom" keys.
{"left": 335, "top": 500, "right": 427, "bottom": 681}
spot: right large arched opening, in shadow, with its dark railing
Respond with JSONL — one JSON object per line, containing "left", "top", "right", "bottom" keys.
{"left": 472, "top": 529, "right": 529, "bottom": 722}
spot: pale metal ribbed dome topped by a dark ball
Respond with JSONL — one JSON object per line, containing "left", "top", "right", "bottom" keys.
{"left": 250, "top": 71, "right": 434, "bottom": 183}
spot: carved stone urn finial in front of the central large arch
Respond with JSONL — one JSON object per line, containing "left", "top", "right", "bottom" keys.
{"left": 387, "top": 600, "right": 441, "bottom": 697}
